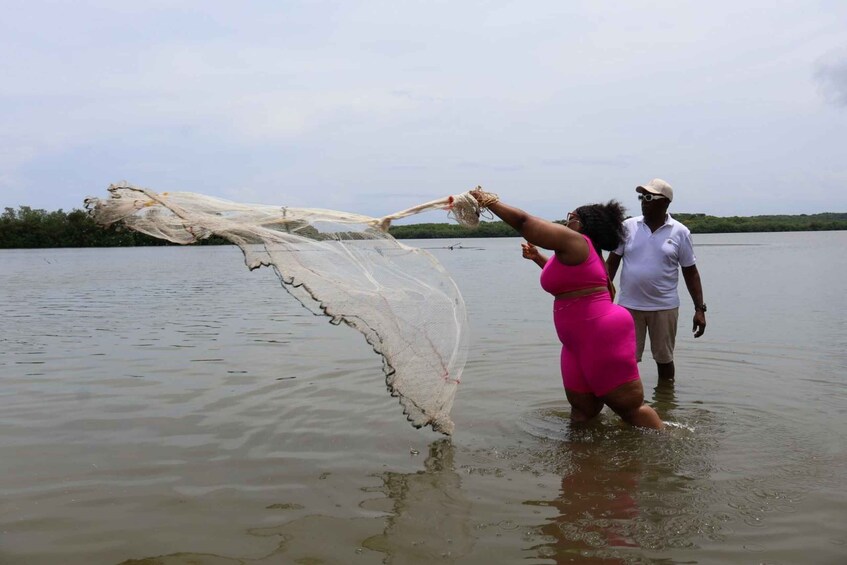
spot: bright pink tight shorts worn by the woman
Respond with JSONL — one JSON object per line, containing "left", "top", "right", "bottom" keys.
{"left": 553, "top": 292, "right": 640, "bottom": 396}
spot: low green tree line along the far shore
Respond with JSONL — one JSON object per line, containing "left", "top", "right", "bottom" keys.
{"left": 0, "top": 206, "right": 847, "bottom": 249}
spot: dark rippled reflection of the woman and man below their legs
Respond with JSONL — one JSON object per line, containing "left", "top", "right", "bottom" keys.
{"left": 525, "top": 396, "right": 727, "bottom": 564}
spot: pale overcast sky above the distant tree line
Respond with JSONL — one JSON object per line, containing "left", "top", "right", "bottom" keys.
{"left": 0, "top": 0, "right": 847, "bottom": 218}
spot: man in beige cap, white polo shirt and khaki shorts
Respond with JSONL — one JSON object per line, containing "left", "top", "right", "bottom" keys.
{"left": 606, "top": 179, "right": 706, "bottom": 382}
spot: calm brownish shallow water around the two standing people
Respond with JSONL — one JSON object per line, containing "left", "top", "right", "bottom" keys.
{"left": 0, "top": 232, "right": 847, "bottom": 564}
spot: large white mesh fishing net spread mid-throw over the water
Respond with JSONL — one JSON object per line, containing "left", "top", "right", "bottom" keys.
{"left": 85, "top": 183, "right": 496, "bottom": 435}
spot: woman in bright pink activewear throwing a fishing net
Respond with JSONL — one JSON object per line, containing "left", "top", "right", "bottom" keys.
{"left": 471, "top": 189, "right": 662, "bottom": 429}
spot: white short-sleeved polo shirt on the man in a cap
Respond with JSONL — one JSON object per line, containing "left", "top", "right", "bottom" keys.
{"left": 614, "top": 214, "right": 697, "bottom": 311}
